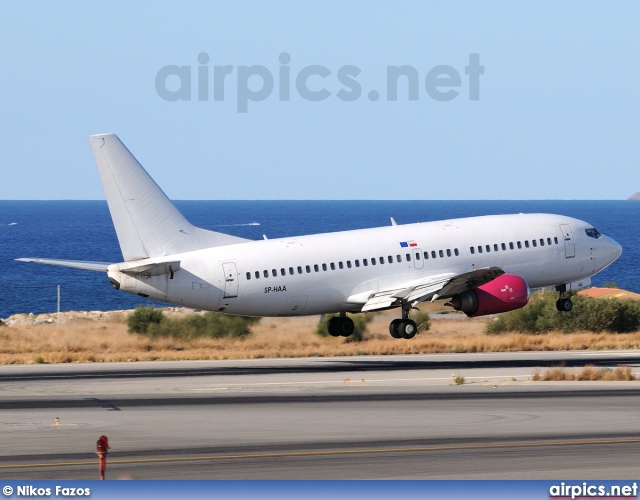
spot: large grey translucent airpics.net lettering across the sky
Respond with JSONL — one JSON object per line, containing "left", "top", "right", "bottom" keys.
{"left": 155, "top": 52, "right": 484, "bottom": 113}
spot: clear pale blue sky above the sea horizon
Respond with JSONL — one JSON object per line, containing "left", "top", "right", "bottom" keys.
{"left": 0, "top": 1, "right": 640, "bottom": 200}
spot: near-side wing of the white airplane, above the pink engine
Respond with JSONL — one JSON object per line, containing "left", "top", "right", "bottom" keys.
{"left": 362, "top": 267, "right": 504, "bottom": 312}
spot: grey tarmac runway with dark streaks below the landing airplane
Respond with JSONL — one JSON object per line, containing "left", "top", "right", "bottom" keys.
{"left": 0, "top": 351, "right": 640, "bottom": 479}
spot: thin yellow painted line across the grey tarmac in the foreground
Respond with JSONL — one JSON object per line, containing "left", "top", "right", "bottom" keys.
{"left": 0, "top": 438, "right": 640, "bottom": 470}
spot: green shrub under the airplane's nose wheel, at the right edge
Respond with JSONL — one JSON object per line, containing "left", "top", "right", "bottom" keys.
{"left": 486, "top": 291, "right": 640, "bottom": 334}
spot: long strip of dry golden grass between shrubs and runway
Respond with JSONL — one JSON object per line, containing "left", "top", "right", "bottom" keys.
{"left": 0, "top": 306, "right": 640, "bottom": 364}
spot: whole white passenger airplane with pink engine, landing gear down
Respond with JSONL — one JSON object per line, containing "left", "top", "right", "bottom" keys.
{"left": 17, "top": 134, "right": 622, "bottom": 339}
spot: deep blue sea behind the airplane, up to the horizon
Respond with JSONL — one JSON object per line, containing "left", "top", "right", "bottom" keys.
{"left": 0, "top": 200, "right": 640, "bottom": 318}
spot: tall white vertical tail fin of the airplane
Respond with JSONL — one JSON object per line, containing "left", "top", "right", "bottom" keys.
{"left": 89, "top": 134, "right": 249, "bottom": 261}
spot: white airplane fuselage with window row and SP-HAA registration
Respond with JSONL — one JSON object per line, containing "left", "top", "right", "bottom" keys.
{"left": 109, "top": 214, "right": 620, "bottom": 316}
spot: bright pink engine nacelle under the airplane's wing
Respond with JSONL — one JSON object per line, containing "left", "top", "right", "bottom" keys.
{"left": 447, "top": 274, "right": 529, "bottom": 317}
